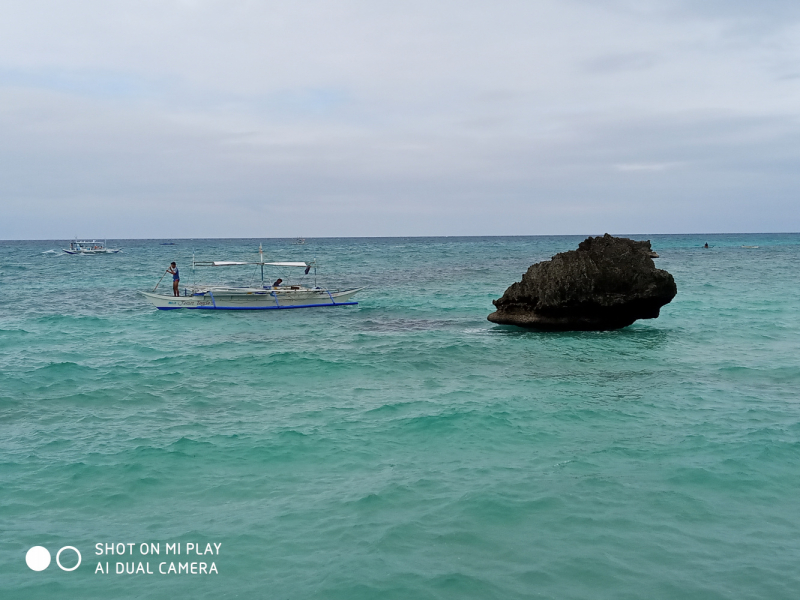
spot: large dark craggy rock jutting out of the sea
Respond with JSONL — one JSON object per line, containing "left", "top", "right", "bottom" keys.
{"left": 489, "top": 234, "right": 678, "bottom": 331}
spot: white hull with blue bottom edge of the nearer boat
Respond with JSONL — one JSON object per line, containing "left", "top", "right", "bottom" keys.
{"left": 139, "top": 288, "right": 364, "bottom": 310}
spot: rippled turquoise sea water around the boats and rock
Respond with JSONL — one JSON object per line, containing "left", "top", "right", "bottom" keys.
{"left": 0, "top": 234, "right": 800, "bottom": 600}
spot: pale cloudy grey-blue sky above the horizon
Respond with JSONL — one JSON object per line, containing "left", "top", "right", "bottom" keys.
{"left": 0, "top": 0, "right": 800, "bottom": 239}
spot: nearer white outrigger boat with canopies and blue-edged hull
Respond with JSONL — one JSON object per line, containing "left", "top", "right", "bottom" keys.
{"left": 139, "top": 247, "right": 364, "bottom": 310}
